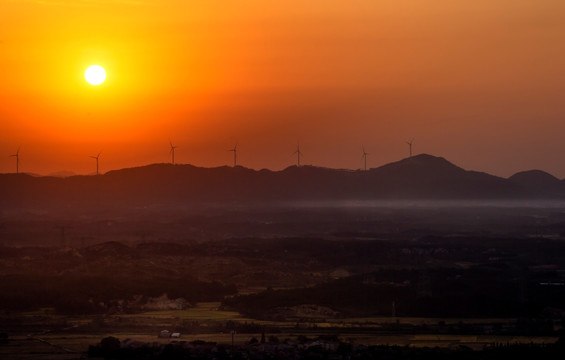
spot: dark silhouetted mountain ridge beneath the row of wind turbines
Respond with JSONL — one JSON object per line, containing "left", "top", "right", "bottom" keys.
{"left": 0, "top": 154, "right": 565, "bottom": 210}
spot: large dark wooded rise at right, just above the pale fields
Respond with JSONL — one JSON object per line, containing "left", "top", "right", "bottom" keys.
{"left": 223, "top": 269, "right": 565, "bottom": 319}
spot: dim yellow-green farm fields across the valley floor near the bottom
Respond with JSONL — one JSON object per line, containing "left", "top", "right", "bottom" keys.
{"left": 0, "top": 302, "right": 558, "bottom": 360}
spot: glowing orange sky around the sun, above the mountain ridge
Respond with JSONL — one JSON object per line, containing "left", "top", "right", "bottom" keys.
{"left": 0, "top": 0, "right": 565, "bottom": 178}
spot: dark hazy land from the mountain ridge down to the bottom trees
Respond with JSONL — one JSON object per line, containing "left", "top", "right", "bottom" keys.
{"left": 0, "top": 155, "right": 565, "bottom": 358}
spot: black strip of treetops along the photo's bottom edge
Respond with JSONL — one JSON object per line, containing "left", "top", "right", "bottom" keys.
{"left": 88, "top": 337, "right": 565, "bottom": 360}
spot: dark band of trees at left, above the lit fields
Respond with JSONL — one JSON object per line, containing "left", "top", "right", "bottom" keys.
{"left": 0, "top": 274, "right": 236, "bottom": 314}
